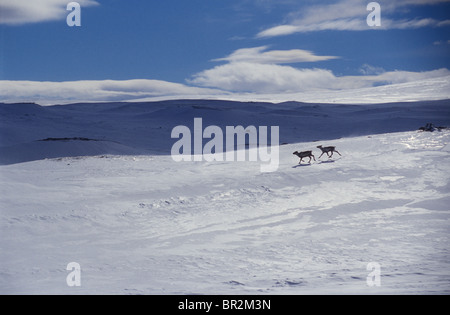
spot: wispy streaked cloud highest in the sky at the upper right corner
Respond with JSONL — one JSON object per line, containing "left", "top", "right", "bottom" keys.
{"left": 257, "top": 0, "right": 450, "bottom": 38}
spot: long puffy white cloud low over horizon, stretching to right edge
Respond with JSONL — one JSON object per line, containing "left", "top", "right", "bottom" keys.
{"left": 189, "top": 62, "right": 450, "bottom": 93}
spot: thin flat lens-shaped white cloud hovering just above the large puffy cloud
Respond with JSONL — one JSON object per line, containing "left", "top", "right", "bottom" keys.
{"left": 214, "top": 46, "right": 338, "bottom": 64}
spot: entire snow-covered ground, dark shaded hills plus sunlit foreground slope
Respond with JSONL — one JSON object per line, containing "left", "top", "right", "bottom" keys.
{"left": 0, "top": 100, "right": 450, "bottom": 295}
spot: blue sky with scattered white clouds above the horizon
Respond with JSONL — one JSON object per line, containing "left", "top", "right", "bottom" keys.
{"left": 0, "top": 0, "right": 450, "bottom": 101}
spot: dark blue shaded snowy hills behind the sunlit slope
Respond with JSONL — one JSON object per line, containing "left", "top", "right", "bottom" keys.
{"left": 0, "top": 100, "right": 450, "bottom": 164}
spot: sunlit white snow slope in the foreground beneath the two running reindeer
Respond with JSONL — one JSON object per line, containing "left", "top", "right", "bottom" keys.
{"left": 0, "top": 131, "right": 450, "bottom": 294}
